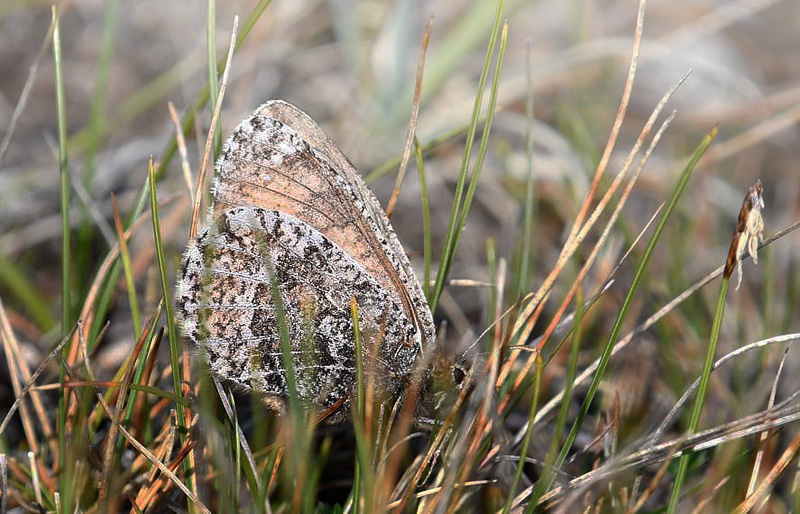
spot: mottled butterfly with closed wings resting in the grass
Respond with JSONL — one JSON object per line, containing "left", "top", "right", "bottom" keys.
{"left": 177, "top": 100, "right": 462, "bottom": 418}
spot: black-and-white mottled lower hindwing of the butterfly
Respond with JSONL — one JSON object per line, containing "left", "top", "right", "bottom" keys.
{"left": 179, "top": 206, "right": 417, "bottom": 408}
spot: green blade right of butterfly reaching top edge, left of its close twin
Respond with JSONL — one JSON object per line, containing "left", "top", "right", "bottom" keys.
{"left": 430, "top": 0, "right": 505, "bottom": 312}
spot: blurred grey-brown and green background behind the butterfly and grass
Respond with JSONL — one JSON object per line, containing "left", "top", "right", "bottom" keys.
{"left": 0, "top": 0, "right": 800, "bottom": 508}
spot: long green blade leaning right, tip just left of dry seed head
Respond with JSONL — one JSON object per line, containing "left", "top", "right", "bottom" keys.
{"left": 543, "top": 127, "right": 719, "bottom": 506}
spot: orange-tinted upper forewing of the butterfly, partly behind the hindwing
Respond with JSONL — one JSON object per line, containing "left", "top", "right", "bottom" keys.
{"left": 209, "top": 101, "right": 435, "bottom": 348}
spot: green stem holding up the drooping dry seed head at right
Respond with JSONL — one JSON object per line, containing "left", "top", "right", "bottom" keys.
{"left": 667, "top": 276, "right": 730, "bottom": 506}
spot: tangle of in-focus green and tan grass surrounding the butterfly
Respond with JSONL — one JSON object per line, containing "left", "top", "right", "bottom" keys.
{"left": 0, "top": 0, "right": 800, "bottom": 514}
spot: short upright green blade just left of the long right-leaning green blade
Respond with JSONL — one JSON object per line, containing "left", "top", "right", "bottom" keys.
{"left": 525, "top": 285, "right": 584, "bottom": 513}
